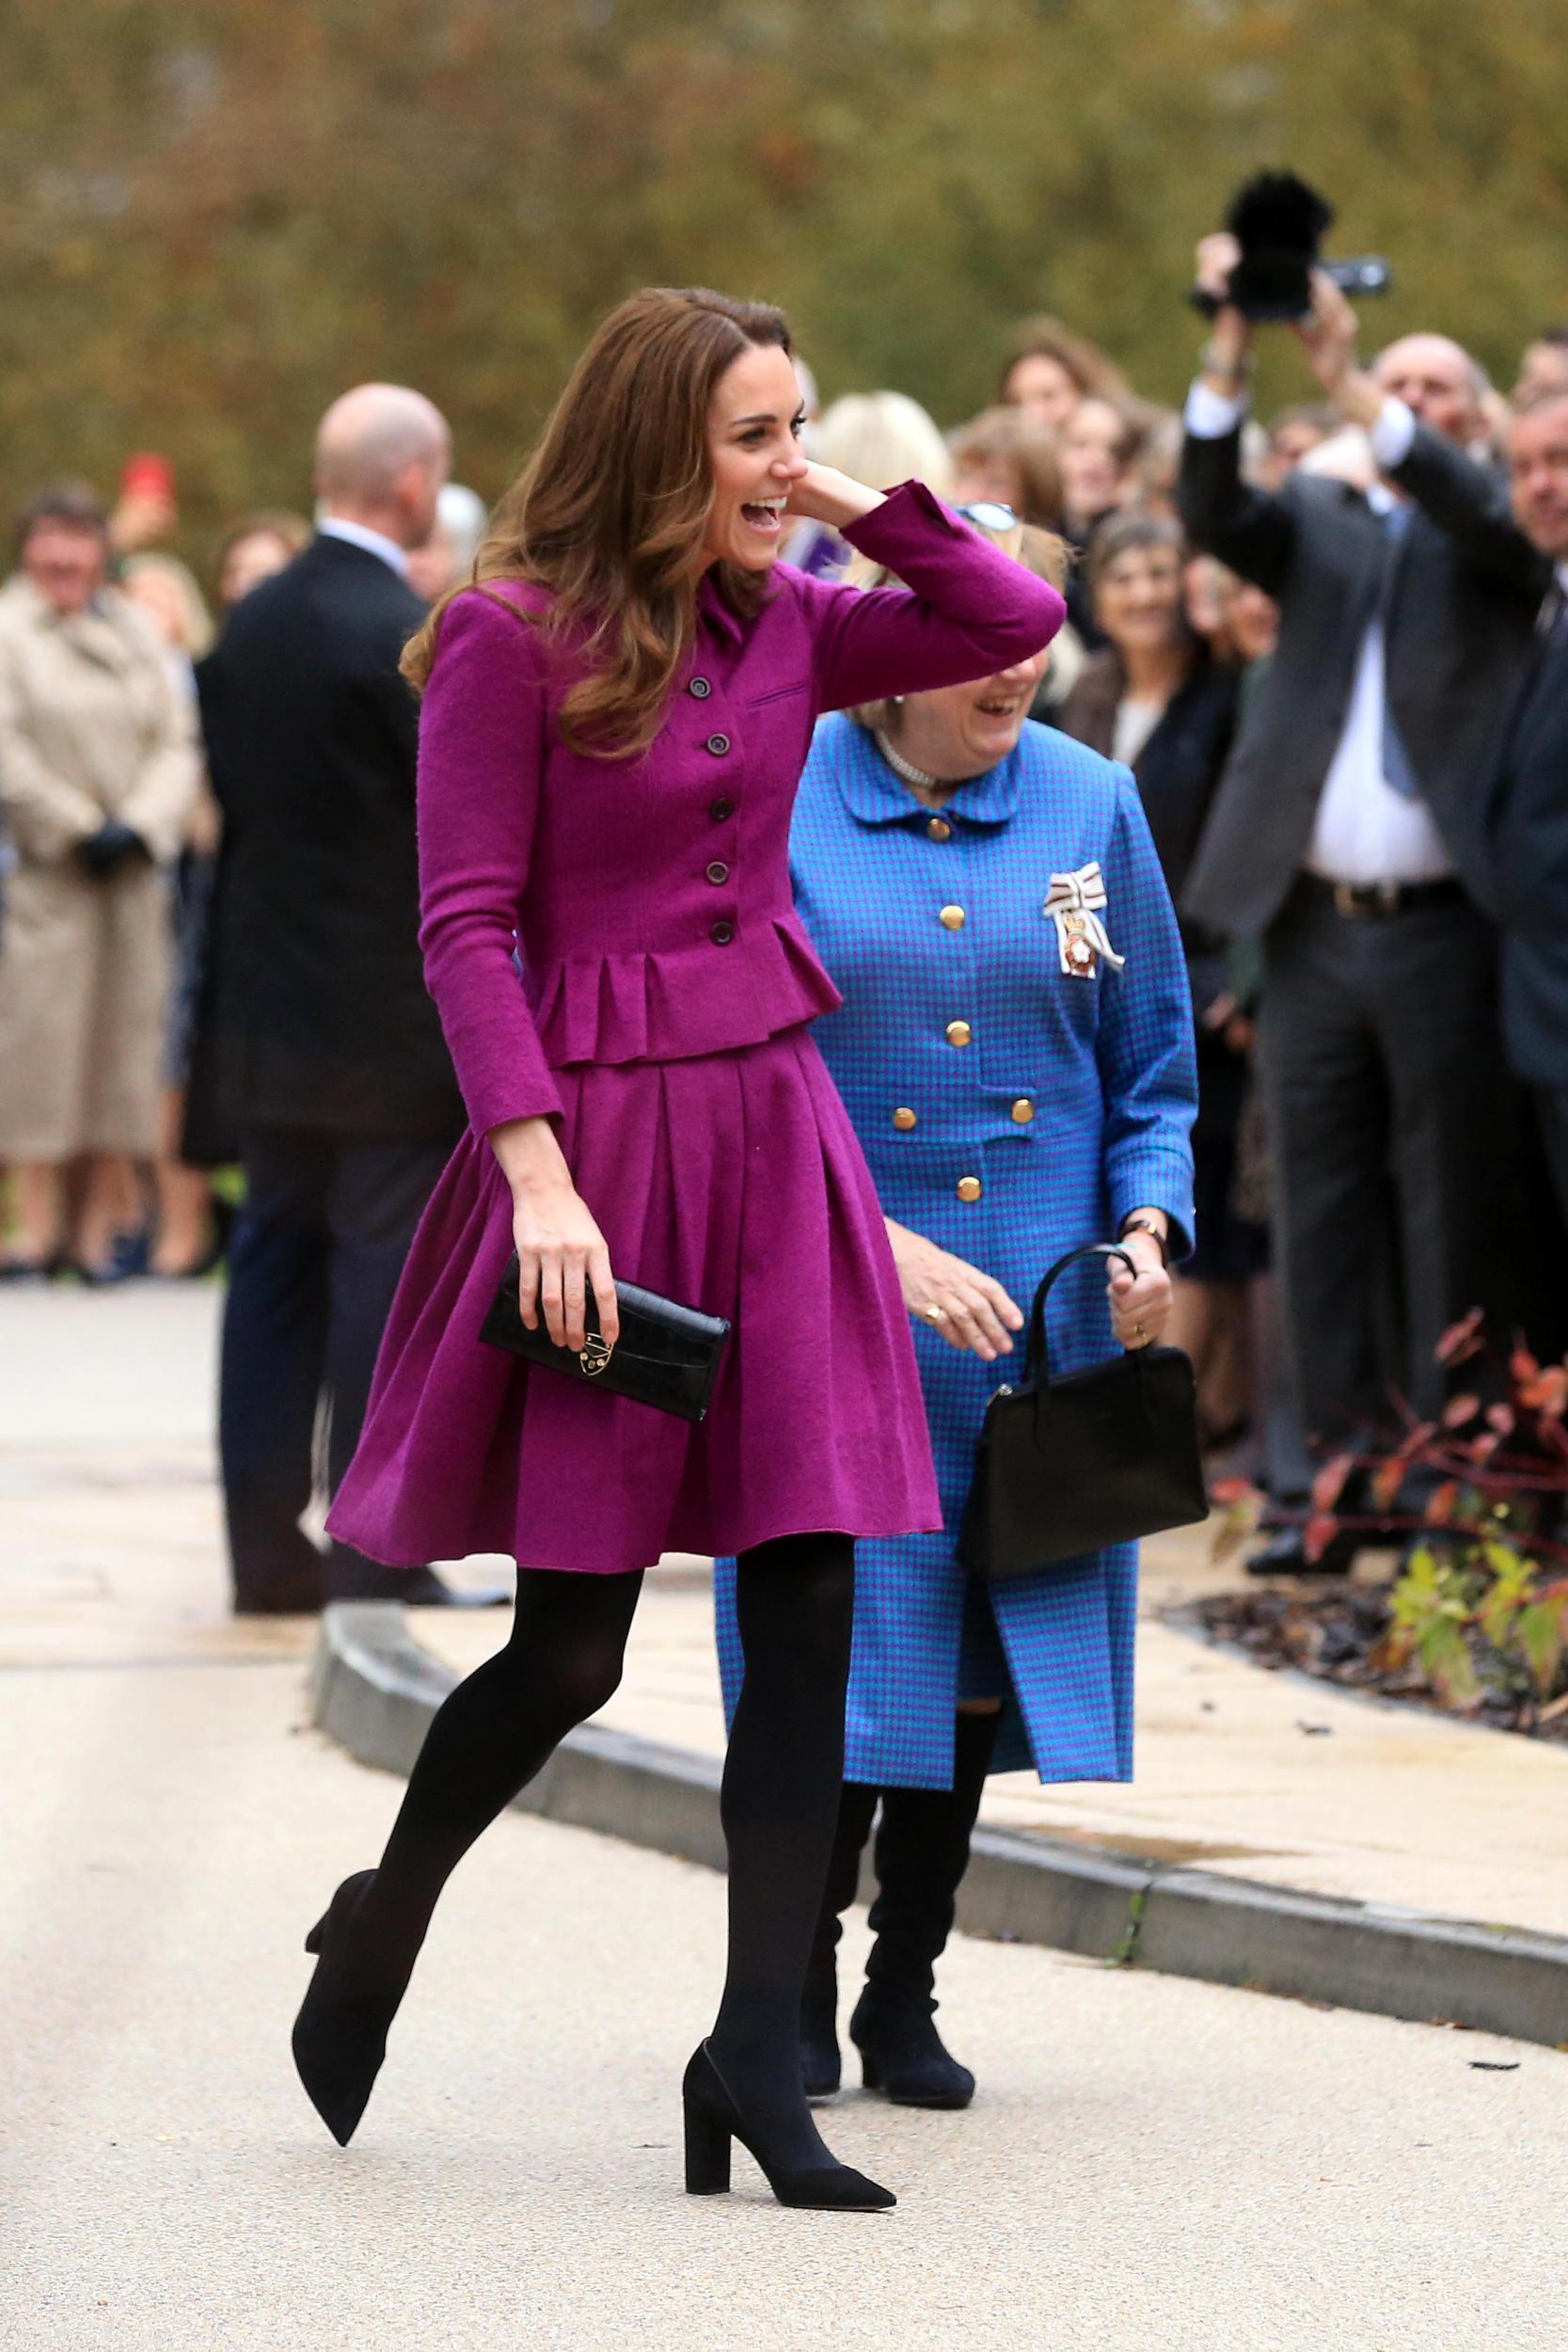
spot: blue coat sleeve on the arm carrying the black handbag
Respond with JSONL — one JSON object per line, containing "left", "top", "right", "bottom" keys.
{"left": 1098, "top": 767, "right": 1196, "bottom": 1256}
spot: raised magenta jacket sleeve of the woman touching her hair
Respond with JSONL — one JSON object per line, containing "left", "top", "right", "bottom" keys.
{"left": 800, "top": 483, "right": 1068, "bottom": 710}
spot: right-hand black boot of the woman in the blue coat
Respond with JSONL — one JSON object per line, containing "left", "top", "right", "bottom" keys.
{"left": 848, "top": 1715, "right": 999, "bottom": 2107}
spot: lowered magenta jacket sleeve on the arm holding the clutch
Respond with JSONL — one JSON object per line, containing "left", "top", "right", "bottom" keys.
{"left": 419, "top": 591, "right": 562, "bottom": 1134}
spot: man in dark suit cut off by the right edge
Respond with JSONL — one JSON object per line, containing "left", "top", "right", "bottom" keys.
{"left": 1488, "top": 386, "right": 1568, "bottom": 1228}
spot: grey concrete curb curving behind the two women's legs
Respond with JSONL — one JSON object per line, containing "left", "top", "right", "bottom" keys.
{"left": 310, "top": 1602, "right": 1568, "bottom": 2046}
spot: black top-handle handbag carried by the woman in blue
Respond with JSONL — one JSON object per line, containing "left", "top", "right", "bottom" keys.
{"left": 959, "top": 1242, "right": 1209, "bottom": 1576}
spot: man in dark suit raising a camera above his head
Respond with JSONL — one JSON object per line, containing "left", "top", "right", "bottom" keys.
{"left": 1180, "top": 240, "right": 1547, "bottom": 1571}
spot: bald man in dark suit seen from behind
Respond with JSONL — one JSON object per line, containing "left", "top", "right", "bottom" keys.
{"left": 193, "top": 384, "right": 486, "bottom": 1612}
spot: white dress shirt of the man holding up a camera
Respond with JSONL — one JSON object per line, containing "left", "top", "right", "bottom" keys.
{"left": 1187, "top": 384, "right": 1455, "bottom": 884}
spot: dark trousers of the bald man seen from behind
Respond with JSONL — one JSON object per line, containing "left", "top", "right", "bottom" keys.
{"left": 218, "top": 1127, "right": 449, "bottom": 1607}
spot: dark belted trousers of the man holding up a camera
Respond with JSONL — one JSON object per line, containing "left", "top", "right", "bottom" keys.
{"left": 1260, "top": 892, "right": 1512, "bottom": 1447}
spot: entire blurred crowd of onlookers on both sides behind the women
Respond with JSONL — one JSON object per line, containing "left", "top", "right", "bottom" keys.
{"left": 0, "top": 270, "right": 1568, "bottom": 1566}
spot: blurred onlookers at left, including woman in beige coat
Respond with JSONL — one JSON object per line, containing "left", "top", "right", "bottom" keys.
{"left": 0, "top": 454, "right": 486, "bottom": 1284}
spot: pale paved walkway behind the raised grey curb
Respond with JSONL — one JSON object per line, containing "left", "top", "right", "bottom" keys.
{"left": 0, "top": 1284, "right": 1568, "bottom": 1933}
